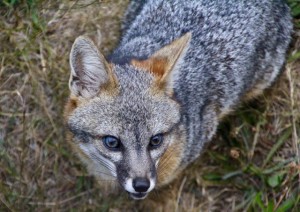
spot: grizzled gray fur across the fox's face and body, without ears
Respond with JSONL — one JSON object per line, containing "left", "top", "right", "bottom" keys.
{"left": 68, "top": 0, "right": 292, "bottom": 199}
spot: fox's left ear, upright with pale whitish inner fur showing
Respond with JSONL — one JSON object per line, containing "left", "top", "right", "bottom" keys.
{"left": 69, "top": 36, "right": 116, "bottom": 98}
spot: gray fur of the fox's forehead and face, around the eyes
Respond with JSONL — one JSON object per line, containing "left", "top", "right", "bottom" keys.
{"left": 68, "top": 65, "right": 180, "bottom": 197}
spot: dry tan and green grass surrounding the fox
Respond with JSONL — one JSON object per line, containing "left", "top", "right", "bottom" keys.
{"left": 0, "top": 0, "right": 300, "bottom": 212}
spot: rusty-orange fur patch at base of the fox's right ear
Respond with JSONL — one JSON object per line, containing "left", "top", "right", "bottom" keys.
{"left": 131, "top": 58, "right": 168, "bottom": 78}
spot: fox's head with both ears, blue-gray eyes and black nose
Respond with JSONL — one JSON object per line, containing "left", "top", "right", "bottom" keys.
{"left": 65, "top": 33, "right": 191, "bottom": 199}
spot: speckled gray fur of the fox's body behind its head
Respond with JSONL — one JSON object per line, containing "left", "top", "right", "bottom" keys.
{"left": 111, "top": 0, "right": 292, "bottom": 164}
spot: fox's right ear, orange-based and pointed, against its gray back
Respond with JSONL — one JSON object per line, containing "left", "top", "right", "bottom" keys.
{"left": 131, "top": 32, "right": 192, "bottom": 94}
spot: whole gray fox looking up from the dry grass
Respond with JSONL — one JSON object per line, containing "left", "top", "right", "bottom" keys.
{"left": 65, "top": 0, "right": 292, "bottom": 199}
